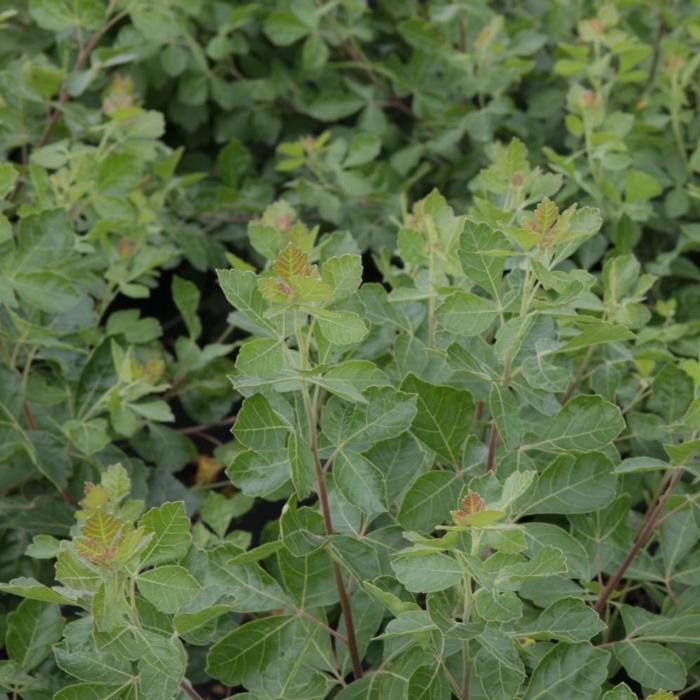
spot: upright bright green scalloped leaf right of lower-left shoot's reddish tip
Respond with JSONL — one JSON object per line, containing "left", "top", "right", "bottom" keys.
{"left": 139, "top": 502, "right": 192, "bottom": 566}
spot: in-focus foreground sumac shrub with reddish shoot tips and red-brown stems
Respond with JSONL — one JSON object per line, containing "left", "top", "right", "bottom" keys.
{"left": 3, "top": 142, "right": 700, "bottom": 700}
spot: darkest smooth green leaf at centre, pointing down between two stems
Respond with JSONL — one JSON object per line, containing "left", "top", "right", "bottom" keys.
{"left": 401, "top": 374, "right": 474, "bottom": 467}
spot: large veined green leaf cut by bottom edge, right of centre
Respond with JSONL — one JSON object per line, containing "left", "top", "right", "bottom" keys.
{"left": 523, "top": 642, "right": 610, "bottom": 700}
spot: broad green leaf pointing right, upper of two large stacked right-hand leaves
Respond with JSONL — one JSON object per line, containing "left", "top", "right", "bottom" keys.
{"left": 521, "top": 396, "right": 625, "bottom": 452}
